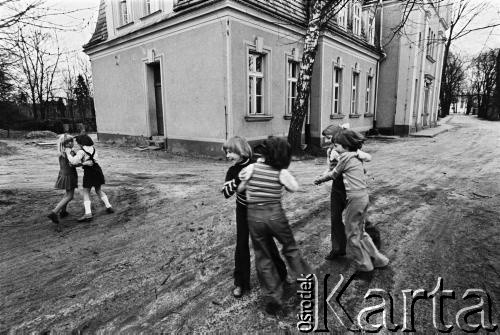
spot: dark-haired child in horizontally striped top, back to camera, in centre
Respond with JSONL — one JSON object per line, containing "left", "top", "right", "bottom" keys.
{"left": 238, "top": 137, "right": 312, "bottom": 314}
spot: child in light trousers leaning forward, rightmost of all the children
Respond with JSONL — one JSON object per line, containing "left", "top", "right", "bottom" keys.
{"left": 314, "top": 129, "right": 389, "bottom": 279}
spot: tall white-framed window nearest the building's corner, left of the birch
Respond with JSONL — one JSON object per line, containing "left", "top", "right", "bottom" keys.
{"left": 248, "top": 51, "right": 265, "bottom": 115}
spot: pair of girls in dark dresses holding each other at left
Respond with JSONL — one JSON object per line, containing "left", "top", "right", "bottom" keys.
{"left": 47, "top": 134, "right": 114, "bottom": 231}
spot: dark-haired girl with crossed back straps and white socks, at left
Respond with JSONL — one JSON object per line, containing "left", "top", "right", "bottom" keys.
{"left": 66, "top": 134, "right": 114, "bottom": 222}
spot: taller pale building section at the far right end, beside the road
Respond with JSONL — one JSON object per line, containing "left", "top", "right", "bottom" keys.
{"left": 376, "top": 0, "right": 450, "bottom": 136}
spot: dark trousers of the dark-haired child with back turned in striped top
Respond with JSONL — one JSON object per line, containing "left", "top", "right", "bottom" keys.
{"left": 248, "top": 203, "right": 312, "bottom": 304}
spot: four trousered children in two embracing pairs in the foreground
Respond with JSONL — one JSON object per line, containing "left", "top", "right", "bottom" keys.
{"left": 222, "top": 126, "right": 389, "bottom": 314}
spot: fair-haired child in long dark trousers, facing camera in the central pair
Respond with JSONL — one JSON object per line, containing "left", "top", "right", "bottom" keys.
{"left": 221, "top": 136, "right": 287, "bottom": 298}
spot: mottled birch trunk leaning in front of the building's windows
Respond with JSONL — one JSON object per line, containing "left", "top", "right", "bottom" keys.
{"left": 288, "top": 1, "right": 327, "bottom": 153}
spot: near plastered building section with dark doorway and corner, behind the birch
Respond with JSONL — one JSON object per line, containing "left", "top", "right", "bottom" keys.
{"left": 84, "top": 0, "right": 381, "bottom": 155}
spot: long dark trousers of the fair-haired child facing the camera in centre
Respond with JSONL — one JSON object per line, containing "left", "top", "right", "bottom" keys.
{"left": 234, "top": 202, "right": 287, "bottom": 291}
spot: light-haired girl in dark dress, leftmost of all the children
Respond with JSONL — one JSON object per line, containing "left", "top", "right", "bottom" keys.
{"left": 47, "top": 134, "right": 78, "bottom": 231}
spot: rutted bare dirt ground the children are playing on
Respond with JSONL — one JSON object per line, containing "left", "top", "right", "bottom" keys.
{"left": 0, "top": 116, "right": 500, "bottom": 333}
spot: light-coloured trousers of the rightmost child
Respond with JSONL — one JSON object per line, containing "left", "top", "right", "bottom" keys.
{"left": 345, "top": 194, "right": 389, "bottom": 271}
